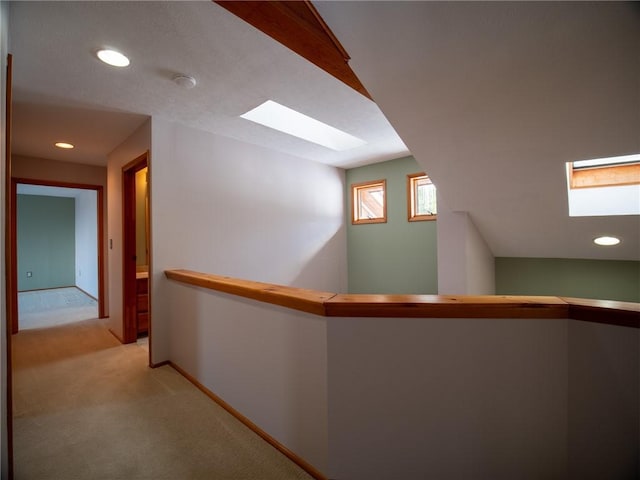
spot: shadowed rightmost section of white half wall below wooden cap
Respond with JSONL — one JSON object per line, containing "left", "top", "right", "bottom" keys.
{"left": 568, "top": 320, "right": 640, "bottom": 480}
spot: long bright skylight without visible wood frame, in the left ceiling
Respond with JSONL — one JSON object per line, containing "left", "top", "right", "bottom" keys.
{"left": 240, "top": 100, "right": 367, "bottom": 151}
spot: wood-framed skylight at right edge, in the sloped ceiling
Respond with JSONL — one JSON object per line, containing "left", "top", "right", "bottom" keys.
{"left": 567, "top": 154, "right": 640, "bottom": 217}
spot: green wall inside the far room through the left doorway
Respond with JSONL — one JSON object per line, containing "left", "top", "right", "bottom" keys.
{"left": 16, "top": 195, "right": 76, "bottom": 291}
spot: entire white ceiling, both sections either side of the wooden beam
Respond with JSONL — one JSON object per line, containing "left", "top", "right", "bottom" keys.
{"left": 9, "top": 0, "right": 640, "bottom": 260}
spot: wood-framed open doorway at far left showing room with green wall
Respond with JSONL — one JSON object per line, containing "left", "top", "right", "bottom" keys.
{"left": 10, "top": 178, "right": 105, "bottom": 333}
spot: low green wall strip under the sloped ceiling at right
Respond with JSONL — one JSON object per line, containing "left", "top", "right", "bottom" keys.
{"left": 496, "top": 257, "right": 640, "bottom": 302}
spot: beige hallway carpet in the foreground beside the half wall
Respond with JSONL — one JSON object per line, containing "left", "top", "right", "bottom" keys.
{"left": 13, "top": 320, "right": 311, "bottom": 480}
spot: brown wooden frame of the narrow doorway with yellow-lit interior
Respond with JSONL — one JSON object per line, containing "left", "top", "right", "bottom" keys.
{"left": 122, "top": 151, "right": 151, "bottom": 343}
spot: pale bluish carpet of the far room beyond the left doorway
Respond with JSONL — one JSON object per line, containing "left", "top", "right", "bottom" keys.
{"left": 18, "top": 287, "right": 98, "bottom": 330}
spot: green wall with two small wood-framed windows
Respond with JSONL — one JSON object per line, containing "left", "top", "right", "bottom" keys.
{"left": 345, "top": 157, "right": 438, "bottom": 294}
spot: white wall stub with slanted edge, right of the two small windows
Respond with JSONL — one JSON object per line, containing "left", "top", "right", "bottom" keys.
{"left": 438, "top": 207, "right": 495, "bottom": 295}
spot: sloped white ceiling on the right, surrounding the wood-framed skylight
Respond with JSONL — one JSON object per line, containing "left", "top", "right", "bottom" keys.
{"left": 315, "top": 1, "right": 640, "bottom": 260}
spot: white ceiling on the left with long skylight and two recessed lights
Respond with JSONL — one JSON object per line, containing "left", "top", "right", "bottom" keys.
{"left": 9, "top": 1, "right": 408, "bottom": 167}
